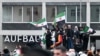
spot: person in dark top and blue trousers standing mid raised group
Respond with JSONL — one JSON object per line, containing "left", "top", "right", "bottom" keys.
{"left": 67, "top": 25, "right": 74, "bottom": 49}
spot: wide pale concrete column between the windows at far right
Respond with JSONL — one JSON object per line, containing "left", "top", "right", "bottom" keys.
{"left": 86, "top": 0, "right": 91, "bottom": 27}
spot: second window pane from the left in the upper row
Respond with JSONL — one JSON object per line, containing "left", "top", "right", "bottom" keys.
{"left": 13, "top": 6, "right": 22, "bottom": 22}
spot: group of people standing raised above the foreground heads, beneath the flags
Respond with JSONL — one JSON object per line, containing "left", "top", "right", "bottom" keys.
{"left": 45, "top": 24, "right": 95, "bottom": 52}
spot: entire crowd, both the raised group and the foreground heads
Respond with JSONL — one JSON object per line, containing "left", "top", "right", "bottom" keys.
{"left": 2, "top": 24, "right": 97, "bottom": 56}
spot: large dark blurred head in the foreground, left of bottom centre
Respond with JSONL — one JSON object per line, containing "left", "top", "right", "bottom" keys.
{"left": 21, "top": 46, "right": 53, "bottom": 56}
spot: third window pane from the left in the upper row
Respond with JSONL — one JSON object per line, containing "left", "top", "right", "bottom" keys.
{"left": 23, "top": 6, "right": 32, "bottom": 22}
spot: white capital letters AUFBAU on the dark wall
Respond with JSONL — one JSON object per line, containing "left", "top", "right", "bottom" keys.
{"left": 3, "top": 35, "right": 40, "bottom": 42}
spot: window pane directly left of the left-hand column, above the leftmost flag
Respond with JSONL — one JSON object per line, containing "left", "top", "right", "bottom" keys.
{"left": 33, "top": 6, "right": 42, "bottom": 22}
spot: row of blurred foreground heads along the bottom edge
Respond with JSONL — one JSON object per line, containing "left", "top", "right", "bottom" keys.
{"left": 0, "top": 46, "right": 100, "bottom": 56}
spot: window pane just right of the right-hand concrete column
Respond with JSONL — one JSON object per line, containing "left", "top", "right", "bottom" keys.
{"left": 91, "top": 6, "right": 100, "bottom": 22}
